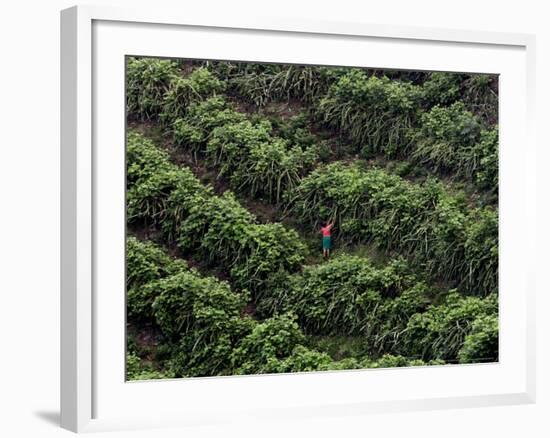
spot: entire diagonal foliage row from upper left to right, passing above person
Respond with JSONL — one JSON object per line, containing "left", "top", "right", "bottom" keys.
{"left": 127, "top": 90, "right": 498, "bottom": 294}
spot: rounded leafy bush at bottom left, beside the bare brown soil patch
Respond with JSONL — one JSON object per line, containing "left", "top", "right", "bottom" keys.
{"left": 150, "top": 270, "right": 251, "bottom": 376}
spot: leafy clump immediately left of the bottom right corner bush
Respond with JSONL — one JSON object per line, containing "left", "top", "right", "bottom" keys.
{"left": 401, "top": 292, "right": 498, "bottom": 361}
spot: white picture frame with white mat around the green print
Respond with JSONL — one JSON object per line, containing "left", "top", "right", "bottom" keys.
{"left": 61, "top": 6, "right": 536, "bottom": 432}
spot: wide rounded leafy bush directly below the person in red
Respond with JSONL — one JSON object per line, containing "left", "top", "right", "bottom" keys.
{"left": 258, "top": 255, "right": 427, "bottom": 338}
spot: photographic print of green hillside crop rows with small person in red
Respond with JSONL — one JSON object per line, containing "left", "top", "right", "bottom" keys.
{"left": 126, "top": 57, "right": 499, "bottom": 380}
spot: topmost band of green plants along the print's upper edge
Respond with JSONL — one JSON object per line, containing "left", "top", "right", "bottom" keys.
{"left": 128, "top": 59, "right": 498, "bottom": 193}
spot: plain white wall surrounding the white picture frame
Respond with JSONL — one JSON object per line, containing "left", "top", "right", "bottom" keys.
{"left": 0, "top": 0, "right": 550, "bottom": 438}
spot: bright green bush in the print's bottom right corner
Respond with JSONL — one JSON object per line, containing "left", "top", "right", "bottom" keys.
{"left": 458, "top": 314, "right": 498, "bottom": 363}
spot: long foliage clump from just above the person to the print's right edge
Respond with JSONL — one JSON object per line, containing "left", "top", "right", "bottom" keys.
{"left": 288, "top": 163, "right": 498, "bottom": 295}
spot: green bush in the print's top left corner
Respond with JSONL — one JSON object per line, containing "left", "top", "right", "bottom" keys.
{"left": 126, "top": 58, "right": 179, "bottom": 120}
